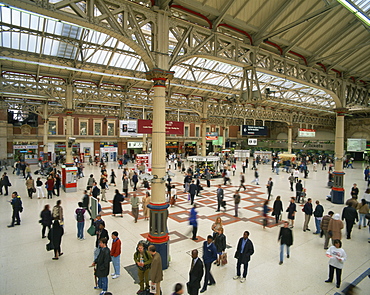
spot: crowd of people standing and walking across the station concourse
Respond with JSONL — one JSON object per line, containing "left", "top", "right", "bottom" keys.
{"left": 0, "top": 157, "right": 370, "bottom": 295}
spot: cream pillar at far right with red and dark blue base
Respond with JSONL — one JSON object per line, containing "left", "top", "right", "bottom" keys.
{"left": 331, "top": 109, "right": 347, "bottom": 204}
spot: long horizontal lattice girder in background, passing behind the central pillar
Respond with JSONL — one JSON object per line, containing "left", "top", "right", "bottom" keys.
{"left": 0, "top": 72, "right": 335, "bottom": 127}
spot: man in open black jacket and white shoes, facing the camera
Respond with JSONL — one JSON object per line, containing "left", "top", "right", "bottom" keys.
{"left": 233, "top": 231, "right": 254, "bottom": 283}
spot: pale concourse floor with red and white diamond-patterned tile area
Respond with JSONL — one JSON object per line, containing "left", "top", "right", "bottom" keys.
{"left": 0, "top": 162, "right": 370, "bottom": 295}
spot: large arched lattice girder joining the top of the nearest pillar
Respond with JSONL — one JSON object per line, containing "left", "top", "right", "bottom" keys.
{"left": 3, "top": 0, "right": 369, "bottom": 107}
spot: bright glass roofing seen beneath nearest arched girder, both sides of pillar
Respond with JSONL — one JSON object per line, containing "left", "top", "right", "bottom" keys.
{"left": 0, "top": 4, "right": 334, "bottom": 108}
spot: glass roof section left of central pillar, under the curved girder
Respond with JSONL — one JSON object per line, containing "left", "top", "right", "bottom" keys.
{"left": 0, "top": 5, "right": 146, "bottom": 71}
